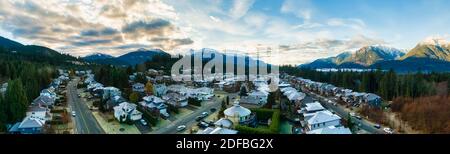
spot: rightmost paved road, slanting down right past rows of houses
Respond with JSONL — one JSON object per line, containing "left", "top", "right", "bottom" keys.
{"left": 305, "top": 91, "right": 385, "bottom": 134}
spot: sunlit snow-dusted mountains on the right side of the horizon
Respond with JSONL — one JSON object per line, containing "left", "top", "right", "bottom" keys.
{"left": 299, "top": 38, "right": 450, "bottom": 72}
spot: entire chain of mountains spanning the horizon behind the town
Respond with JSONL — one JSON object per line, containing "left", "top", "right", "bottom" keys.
{"left": 0, "top": 36, "right": 450, "bottom": 72}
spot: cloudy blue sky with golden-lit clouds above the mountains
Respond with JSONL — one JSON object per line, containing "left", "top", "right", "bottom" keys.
{"left": 0, "top": 0, "right": 450, "bottom": 64}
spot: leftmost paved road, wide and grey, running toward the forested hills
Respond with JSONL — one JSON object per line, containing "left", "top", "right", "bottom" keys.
{"left": 67, "top": 78, "right": 104, "bottom": 134}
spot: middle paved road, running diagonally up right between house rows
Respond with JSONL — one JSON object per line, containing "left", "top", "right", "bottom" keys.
{"left": 151, "top": 94, "right": 222, "bottom": 134}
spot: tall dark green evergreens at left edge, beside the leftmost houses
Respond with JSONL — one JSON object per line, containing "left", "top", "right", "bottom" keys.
{"left": 0, "top": 49, "right": 56, "bottom": 132}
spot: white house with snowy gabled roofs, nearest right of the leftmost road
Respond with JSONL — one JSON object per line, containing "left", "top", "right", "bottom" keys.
{"left": 114, "top": 102, "right": 142, "bottom": 122}
